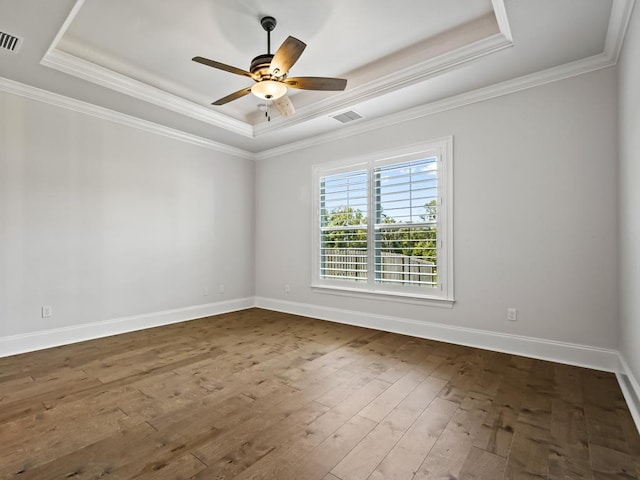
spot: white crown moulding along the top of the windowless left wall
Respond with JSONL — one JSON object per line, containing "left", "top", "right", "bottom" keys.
{"left": 0, "top": 77, "right": 255, "bottom": 160}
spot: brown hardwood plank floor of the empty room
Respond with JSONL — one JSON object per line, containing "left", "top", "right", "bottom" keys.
{"left": 0, "top": 309, "right": 640, "bottom": 480}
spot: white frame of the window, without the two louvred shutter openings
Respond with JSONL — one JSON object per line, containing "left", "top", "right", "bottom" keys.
{"left": 311, "top": 137, "right": 455, "bottom": 308}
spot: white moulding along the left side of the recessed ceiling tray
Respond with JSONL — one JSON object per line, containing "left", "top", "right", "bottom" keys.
{"left": 40, "top": 50, "right": 253, "bottom": 138}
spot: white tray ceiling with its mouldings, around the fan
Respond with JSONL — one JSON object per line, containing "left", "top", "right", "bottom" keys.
{"left": 0, "top": 0, "right": 633, "bottom": 156}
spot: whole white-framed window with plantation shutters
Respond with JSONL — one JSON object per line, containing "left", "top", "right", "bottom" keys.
{"left": 312, "top": 138, "right": 453, "bottom": 304}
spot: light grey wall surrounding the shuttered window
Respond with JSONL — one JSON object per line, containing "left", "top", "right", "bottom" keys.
{"left": 256, "top": 69, "right": 618, "bottom": 349}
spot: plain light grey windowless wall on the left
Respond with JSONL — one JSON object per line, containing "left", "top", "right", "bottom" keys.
{"left": 0, "top": 89, "right": 254, "bottom": 353}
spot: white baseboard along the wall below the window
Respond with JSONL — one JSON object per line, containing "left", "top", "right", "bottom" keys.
{"left": 255, "top": 297, "right": 619, "bottom": 372}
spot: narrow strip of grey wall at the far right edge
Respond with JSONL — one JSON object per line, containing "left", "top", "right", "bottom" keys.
{"left": 618, "top": 5, "right": 640, "bottom": 388}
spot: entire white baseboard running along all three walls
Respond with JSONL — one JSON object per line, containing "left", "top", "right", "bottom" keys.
{"left": 0, "top": 297, "right": 640, "bottom": 431}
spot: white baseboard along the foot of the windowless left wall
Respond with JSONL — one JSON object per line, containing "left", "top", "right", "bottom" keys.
{"left": 0, "top": 297, "right": 254, "bottom": 358}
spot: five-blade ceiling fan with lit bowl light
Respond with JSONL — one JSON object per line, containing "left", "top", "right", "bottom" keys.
{"left": 192, "top": 17, "right": 347, "bottom": 120}
